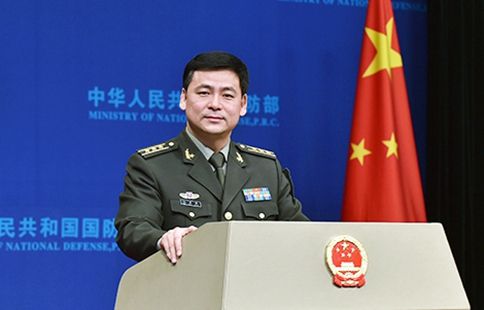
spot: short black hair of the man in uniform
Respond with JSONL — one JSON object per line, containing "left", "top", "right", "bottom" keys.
{"left": 183, "top": 51, "right": 249, "bottom": 95}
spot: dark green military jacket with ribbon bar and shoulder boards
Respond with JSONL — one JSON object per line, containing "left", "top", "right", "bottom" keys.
{"left": 115, "top": 132, "right": 308, "bottom": 260}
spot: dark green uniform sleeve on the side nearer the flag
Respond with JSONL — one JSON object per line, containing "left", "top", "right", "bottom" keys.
{"left": 276, "top": 160, "right": 309, "bottom": 221}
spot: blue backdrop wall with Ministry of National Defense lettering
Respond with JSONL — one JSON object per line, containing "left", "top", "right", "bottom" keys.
{"left": 0, "top": 0, "right": 427, "bottom": 309}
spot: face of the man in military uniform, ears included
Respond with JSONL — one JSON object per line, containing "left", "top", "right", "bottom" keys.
{"left": 180, "top": 70, "right": 247, "bottom": 137}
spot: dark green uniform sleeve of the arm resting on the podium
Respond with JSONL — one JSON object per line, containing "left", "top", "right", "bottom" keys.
{"left": 115, "top": 154, "right": 165, "bottom": 261}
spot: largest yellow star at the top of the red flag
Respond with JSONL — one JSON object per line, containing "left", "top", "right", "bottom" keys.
{"left": 363, "top": 17, "right": 403, "bottom": 77}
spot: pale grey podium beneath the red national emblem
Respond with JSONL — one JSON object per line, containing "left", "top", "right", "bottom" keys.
{"left": 116, "top": 222, "right": 470, "bottom": 310}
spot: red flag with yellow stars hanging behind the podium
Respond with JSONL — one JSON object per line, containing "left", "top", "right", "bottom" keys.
{"left": 342, "top": 0, "right": 426, "bottom": 222}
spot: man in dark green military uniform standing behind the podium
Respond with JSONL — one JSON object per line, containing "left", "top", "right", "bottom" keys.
{"left": 115, "top": 52, "right": 308, "bottom": 263}
